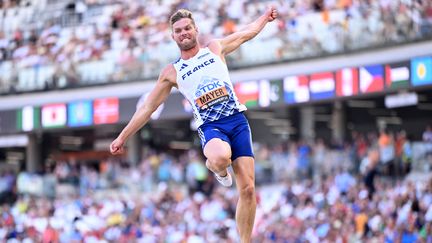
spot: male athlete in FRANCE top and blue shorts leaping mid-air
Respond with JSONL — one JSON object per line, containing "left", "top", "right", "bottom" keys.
{"left": 110, "top": 7, "right": 277, "bottom": 243}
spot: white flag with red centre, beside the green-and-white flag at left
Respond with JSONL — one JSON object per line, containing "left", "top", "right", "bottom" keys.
{"left": 42, "top": 104, "right": 66, "bottom": 128}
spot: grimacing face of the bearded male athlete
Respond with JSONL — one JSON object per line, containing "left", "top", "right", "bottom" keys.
{"left": 172, "top": 18, "right": 198, "bottom": 51}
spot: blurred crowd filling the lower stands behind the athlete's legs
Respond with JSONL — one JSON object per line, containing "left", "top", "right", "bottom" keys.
{"left": 0, "top": 128, "right": 432, "bottom": 243}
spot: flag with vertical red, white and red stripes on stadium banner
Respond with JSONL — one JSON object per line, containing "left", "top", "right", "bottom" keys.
{"left": 336, "top": 68, "right": 358, "bottom": 96}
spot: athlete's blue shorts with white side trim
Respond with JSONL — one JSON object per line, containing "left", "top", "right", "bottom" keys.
{"left": 198, "top": 112, "right": 254, "bottom": 160}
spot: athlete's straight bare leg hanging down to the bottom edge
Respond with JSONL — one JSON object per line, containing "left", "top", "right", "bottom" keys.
{"left": 232, "top": 157, "right": 256, "bottom": 243}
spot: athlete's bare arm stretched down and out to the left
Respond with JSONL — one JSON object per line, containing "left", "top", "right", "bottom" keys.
{"left": 110, "top": 64, "right": 176, "bottom": 154}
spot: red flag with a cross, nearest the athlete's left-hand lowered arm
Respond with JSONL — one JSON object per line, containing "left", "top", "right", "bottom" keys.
{"left": 93, "top": 98, "right": 119, "bottom": 125}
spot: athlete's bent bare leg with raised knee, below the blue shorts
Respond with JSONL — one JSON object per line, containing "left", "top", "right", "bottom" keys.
{"left": 204, "top": 138, "right": 231, "bottom": 177}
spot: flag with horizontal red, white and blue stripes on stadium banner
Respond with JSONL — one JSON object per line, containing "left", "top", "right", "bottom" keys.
{"left": 309, "top": 72, "right": 335, "bottom": 100}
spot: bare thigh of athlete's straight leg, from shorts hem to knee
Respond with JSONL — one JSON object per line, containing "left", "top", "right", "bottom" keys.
{"left": 232, "top": 156, "right": 255, "bottom": 189}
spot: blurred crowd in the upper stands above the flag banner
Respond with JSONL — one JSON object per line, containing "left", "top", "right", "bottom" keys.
{"left": 0, "top": 0, "right": 432, "bottom": 93}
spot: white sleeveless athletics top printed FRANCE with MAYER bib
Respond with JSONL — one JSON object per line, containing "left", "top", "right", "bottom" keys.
{"left": 173, "top": 47, "right": 246, "bottom": 126}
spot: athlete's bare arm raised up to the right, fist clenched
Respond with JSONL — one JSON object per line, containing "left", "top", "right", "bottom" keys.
{"left": 209, "top": 6, "right": 278, "bottom": 55}
